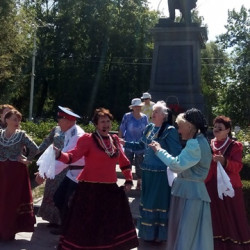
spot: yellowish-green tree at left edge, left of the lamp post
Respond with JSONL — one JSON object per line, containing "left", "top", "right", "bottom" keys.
{"left": 0, "top": 0, "right": 36, "bottom": 114}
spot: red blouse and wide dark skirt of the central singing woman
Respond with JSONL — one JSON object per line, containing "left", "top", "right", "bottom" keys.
{"left": 58, "top": 132, "right": 138, "bottom": 250}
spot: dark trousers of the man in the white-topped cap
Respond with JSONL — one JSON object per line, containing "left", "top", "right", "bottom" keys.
{"left": 54, "top": 176, "right": 78, "bottom": 224}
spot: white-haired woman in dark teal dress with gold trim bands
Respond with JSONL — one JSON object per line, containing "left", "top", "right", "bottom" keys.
{"left": 121, "top": 101, "right": 181, "bottom": 242}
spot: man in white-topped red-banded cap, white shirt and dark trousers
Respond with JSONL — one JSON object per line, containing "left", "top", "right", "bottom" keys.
{"left": 36, "top": 106, "right": 85, "bottom": 234}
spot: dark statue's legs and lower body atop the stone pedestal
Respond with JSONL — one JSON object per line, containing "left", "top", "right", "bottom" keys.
{"left": 168, "top": 0, "right": 197, "bottom": 24}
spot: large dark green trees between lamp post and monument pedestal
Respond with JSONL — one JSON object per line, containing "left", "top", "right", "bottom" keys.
{"left": 31, "top": 0, "right": 157, "bottom": 118}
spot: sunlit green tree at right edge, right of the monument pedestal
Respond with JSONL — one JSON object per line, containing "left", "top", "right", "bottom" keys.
{"left": 214, "top": 6, "right": 250, "bottom": 126}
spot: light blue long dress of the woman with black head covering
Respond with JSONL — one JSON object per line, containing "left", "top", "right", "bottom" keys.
{"left": 156, "top": 134, "right": 214, "bottom": 250}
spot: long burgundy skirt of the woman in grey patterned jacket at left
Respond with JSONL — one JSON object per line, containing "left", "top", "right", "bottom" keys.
{"left": 0, "top": 160, "right": 36, "bottom": 240}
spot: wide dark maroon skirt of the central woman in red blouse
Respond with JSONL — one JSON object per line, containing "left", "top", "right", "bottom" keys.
{"left": 58, "top": 182, "right": 138, "bottom": 250}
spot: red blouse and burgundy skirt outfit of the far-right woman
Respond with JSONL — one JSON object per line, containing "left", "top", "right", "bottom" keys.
{"left": 206, "top": 137, "right": 250, "bottom": 250}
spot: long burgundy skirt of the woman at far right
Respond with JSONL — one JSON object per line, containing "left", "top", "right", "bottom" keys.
{"left": 206, "top": 179, "right": 250, "bottom": 250}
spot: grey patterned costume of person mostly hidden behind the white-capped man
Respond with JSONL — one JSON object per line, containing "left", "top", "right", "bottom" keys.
{"left": 38, "top": 126, "right": 67, "bottom": 225}
